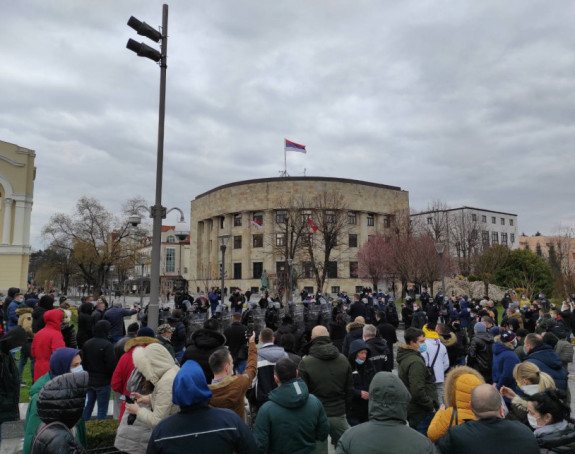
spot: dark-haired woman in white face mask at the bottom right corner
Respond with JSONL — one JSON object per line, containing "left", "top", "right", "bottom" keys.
{"left": 526, "top": 389, "right": 575, "bottom": 454}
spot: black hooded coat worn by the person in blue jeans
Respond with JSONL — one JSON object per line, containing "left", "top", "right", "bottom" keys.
{"left": 81, "top": 320, "right": 116, "bottom": 387}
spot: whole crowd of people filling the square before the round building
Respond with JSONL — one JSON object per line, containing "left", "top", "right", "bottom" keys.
{"left": 0, "top": 289, "right": 575, "bottom": 454}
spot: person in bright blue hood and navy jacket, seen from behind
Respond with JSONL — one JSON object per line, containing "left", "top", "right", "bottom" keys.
{"left": 146, "top": 360, "right": 257, "bottom": 454}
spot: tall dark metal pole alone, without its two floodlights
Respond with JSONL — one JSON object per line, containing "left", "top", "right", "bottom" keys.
{"left": 148, "top": 5, "right": 168, "bottom": 330}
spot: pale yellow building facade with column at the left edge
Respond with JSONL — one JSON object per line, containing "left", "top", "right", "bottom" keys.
{"left": 0, "top": 141, "right": 36, "bottom": 291}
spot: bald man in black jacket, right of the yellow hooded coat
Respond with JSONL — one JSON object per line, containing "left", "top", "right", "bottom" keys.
{"left": 439, "top": 384, "right": 539, "bottom": 454}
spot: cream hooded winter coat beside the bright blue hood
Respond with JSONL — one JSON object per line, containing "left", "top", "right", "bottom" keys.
{"left": 132, "top": 344, "right": 180, "bottom": 427}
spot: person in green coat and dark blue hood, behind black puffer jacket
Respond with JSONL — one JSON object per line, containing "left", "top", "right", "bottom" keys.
{"left": 22, "top": 348, "right": 87, "bottom": 454}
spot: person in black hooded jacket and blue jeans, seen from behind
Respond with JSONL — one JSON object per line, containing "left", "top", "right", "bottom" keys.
{"left": 82, "top": 320, "right": 116, "bottom": 421}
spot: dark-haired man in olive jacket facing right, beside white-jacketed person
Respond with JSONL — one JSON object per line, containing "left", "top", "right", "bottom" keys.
{"left": 397, "top": 328, "right": 439, "bottom": 435}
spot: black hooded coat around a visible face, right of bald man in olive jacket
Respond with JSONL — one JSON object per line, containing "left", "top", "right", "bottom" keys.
{"left": 347, "top": 339, "right": 376, "bottom": 422}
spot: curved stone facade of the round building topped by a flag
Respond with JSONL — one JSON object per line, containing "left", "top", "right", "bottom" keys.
{"left": 187, "top": 177, "right": 409, "bottom": 293}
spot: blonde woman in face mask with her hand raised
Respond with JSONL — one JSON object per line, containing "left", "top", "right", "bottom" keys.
{"left": 499, "top": 362, "right": 556, "bottom": 424}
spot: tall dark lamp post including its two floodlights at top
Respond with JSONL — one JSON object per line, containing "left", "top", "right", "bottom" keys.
{"left": 126, "top": 5, "right": 168, "bottom": 330}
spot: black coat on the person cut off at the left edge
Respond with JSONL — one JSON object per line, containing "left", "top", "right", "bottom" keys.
{"left": 0, "top": 326, "right": 28, "bottom": 423}
